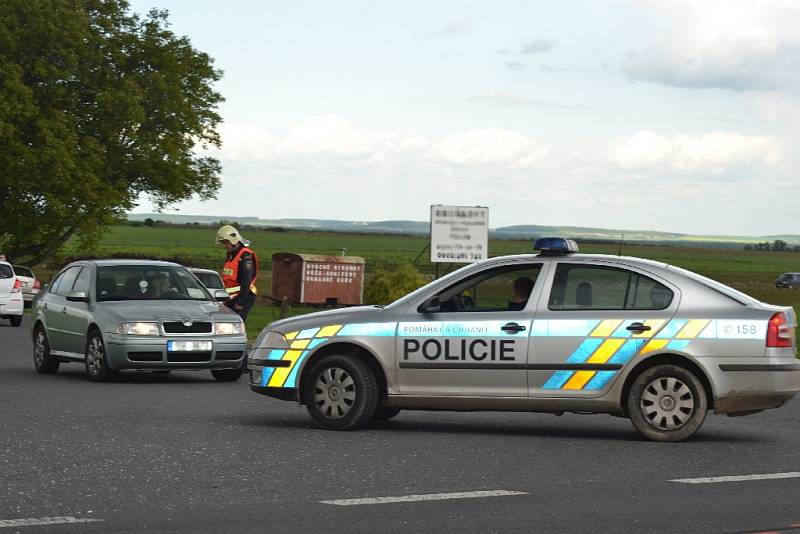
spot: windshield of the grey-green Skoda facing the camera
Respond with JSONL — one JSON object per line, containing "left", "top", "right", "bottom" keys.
{"left": 97, "top": 265, "right": 212, "bottom": 302}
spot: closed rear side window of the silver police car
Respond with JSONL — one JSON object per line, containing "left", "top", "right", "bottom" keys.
{"left": 548, "top": 263, "right": 673, "bottom": 310}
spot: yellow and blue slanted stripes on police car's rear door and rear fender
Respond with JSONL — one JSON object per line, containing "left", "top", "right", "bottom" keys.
{"left": 531, "top": 319, "right": 711, "bottom": 391}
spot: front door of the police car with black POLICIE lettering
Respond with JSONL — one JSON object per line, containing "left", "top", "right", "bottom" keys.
{"left": 395, "top": 262, "right": 542, "bottom": 397}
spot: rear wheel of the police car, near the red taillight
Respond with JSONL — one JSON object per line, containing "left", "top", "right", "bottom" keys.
{"left": 626, "top": 364, "right": 708, "bottom": 441}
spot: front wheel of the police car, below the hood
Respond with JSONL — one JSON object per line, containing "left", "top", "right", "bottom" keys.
{"left": 303, "top": 355, "right": 379, "bottom": 430}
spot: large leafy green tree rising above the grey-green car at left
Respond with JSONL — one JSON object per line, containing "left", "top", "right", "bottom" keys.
{"left": 0, "top": 0, "right": 223, "bottom": 264}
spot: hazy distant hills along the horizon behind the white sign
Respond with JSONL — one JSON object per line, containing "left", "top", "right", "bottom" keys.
{"left": 128, "top": 213, "right": 800, "bottom": 247}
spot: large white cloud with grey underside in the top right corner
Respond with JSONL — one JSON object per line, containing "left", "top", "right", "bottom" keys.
{"left": 623, "top": 0, "right": 800, "bottom": 90}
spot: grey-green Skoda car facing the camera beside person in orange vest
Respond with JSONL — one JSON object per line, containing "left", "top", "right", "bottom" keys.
{"left": 32, "top": 260, "right": 247, "bottom": 381}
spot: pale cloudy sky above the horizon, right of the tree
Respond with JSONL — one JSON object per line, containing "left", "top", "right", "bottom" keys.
{"left": 131, "top": 0, "right": 800, "bottom": 235}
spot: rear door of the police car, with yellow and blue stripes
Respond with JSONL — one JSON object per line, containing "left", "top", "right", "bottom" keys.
{"left": 528, "top": 259, "right": 680, "bottom": 397}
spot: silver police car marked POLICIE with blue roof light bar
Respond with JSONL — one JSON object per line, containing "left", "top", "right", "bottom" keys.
{"left": 248, "top": 238, "right": 800, "bottom": 441}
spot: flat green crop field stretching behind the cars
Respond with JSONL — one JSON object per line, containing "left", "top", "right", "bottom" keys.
{"left": 51, "top": 226, "right": 800, "bottom": 342}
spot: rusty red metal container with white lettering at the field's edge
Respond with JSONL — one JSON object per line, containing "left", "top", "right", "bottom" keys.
{"left": 272, "top": 252, "right": 365, "bottom": 306}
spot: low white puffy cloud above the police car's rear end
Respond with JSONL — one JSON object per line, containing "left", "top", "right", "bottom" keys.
{"left": 613, "top": 130, "right": 780, "bottom": 176}
